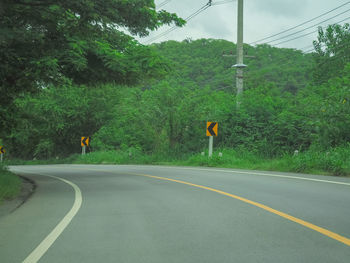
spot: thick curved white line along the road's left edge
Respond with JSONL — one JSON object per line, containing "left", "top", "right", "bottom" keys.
{"left": 16, "top": 170, "right": 83, "bottom": 263}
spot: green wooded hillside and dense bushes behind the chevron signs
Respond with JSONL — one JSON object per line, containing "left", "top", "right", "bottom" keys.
{"left": 3, "top": 21, "right": 350, "bottom": 175}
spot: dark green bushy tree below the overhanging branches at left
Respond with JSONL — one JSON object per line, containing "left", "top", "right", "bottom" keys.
{"left": 5, "top": 84, "right": 121, "bottom": 158}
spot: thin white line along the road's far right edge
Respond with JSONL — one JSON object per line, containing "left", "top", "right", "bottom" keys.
{"left": 70, "top": 164, "right": 350, "bottom": 186}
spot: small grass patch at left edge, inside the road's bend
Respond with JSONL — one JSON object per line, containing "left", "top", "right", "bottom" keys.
{"left": 0, "top": 165, "right": 21, "bottom": 203}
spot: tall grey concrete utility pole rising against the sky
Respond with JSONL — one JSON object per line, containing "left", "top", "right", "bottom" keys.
{"left": 233, "top": 0, "right": 246, "bottom": 108}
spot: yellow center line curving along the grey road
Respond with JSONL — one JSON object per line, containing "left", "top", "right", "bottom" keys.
{"left": 73, "top": 168, "right": 350, "bottom": 249}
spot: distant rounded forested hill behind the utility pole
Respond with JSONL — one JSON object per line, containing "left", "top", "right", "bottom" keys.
{"left": 154, "top": 39, "right": 313, "bottom": 93}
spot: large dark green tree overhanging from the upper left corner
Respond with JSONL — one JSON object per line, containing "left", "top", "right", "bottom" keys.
{"left": 0, "top": 0, "right": 185, "bottom": 131}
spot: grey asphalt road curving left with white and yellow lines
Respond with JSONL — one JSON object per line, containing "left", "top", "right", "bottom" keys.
{"left": 0, "top": 165, "right": 350, "bottom": 263}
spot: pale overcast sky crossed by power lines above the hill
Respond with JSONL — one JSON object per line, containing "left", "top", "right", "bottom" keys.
{"left": 140, "top": 0, "right": 350, "bottom": 50}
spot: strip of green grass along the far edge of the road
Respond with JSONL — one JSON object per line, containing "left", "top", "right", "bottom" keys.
{"left": 5, "top": 144, "right": 350, "bottom": 176}
